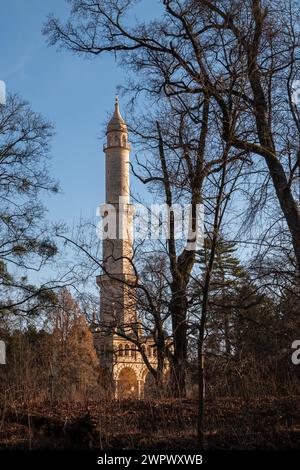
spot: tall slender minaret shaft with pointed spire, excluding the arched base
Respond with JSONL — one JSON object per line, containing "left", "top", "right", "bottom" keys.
{"left": 97, "top": 98, "right": 135, "bottom": 330}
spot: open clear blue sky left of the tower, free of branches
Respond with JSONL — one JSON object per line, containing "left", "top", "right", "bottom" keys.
{"left": 0, "top": 0, "right": 162, "bottom": 225}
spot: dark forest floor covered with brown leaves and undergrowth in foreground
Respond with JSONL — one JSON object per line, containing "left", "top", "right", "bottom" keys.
{"left": 0, "top": 396, "right": 300, "bottom": 451}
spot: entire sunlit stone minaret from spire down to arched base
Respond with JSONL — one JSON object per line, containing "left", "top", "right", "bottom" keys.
{"left": 94, "top": 99, "right": 163, "bottom": 398}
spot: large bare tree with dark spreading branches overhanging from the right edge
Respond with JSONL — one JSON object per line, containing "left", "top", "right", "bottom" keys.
{"left": 45, "top": 0, "right": 300, "bottom": 276}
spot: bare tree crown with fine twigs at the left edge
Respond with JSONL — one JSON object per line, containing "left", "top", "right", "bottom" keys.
{"left": 0, "top": 95, "right": 58, "bottom": 315}
